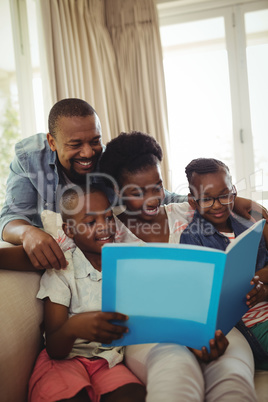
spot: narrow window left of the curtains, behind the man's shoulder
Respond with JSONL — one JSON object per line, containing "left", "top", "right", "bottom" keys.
{"left": 0, "top": 0, "right": 46, "bottom": 208}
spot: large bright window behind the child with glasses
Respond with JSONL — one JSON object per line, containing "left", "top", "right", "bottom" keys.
{"left": 158, "top": 0, "right": 268, "bottom": 206}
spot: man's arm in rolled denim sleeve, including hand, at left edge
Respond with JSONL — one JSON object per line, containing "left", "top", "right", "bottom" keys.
{"left": 0, "top": 144, "right": 66, "bottom": 269}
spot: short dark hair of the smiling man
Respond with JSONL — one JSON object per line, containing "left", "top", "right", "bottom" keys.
{"left": 48, "top": 98, "right": 97, "bottom": 138}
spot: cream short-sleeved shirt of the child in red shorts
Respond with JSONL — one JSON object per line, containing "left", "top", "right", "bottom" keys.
{"left": 37, "top": 230, "right": 124, "bottom": 367}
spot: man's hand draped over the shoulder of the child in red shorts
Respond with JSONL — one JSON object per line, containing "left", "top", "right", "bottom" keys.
{"left": 22, "top": 225, "right": 67, "bottom": 270}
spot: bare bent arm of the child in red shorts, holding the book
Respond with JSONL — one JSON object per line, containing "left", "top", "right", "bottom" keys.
{"left": 45, "top": 298, "right": 128, "bottom": 359}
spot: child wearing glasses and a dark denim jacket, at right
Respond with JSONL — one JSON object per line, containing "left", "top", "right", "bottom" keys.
{"left": 181, "top": 158, "right": 268, "bottom": 370}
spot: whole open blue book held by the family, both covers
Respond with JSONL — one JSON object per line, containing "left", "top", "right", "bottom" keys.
{"left": 102, "top": 220, "right": 265, "bottom": 349}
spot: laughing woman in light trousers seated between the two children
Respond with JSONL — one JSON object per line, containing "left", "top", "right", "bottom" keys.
{"left": 100, "top": 132, "right": 256, "bottom": 402}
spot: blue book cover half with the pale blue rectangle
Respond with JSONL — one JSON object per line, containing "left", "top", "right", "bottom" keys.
{"left": 102, "top": 243, "right": 226, "bottom": 348}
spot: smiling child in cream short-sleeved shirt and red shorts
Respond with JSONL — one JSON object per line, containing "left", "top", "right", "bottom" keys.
{"left": 29, "top": 186, "right": 145, "bottom": 402}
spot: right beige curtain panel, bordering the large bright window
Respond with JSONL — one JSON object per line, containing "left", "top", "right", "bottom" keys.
{"left": 105, "top": 0, "right": 170, "bottom": 188}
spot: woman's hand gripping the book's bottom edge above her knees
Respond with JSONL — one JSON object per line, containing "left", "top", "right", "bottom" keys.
{"left": 189, "top": 330, "right": 229, "bottom": 363}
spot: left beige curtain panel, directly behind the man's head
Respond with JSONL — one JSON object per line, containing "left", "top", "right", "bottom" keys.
{"left": 38, "top": 0, "right": 126, "bottom": 143}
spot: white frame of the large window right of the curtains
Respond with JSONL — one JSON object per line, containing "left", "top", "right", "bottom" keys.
{"left": 156, "top": 0, "right": 268, "bottom": 200}
